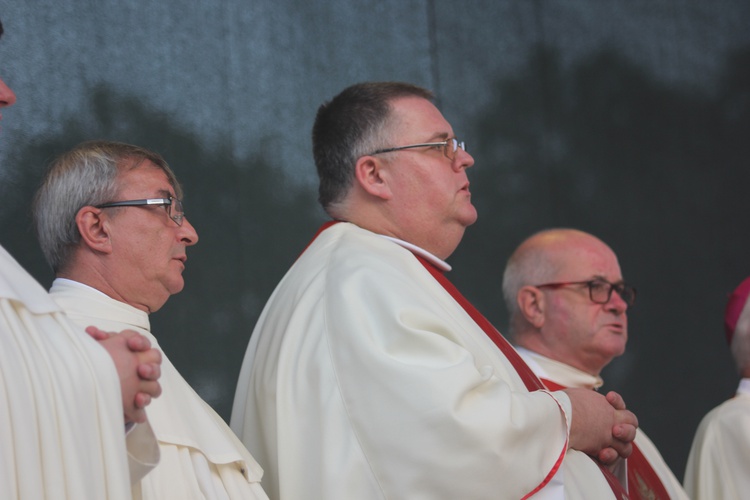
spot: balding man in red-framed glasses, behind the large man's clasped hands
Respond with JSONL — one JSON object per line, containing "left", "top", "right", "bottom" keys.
{"left": 503, "top": 228, "right": 687, "bottom": 499}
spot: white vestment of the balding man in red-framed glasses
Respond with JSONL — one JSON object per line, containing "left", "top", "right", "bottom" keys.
{"left": 517, "top": 347, "right": 688, "bottom": 500}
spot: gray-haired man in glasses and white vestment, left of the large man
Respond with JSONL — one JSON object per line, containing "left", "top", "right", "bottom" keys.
{"left": 34, "top": 141, "right": 267, "bottom": 500}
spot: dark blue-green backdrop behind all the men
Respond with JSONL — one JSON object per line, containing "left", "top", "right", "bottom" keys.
{"left": 0, "top": 0, "right": 750, "bottom": 478}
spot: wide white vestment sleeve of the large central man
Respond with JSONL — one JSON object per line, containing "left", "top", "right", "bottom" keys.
{"left": 323, "top": 248, "right": 569, "bottom": 498}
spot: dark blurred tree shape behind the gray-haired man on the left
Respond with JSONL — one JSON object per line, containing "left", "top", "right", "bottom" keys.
{"left": 0, "top": 87, "right": 324, "bottom": 419}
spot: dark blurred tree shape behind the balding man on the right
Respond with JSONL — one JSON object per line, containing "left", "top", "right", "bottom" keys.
{"left": 451, "top": 46, "right": 750, "bottom": 477}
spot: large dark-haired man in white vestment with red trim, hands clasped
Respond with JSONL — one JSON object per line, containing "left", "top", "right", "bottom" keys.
{"left": 231, "top": 82, "right": 637, "bottom": 500}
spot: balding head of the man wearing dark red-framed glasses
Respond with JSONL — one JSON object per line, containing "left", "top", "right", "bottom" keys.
{"left": 503, "top": 229, "right": 627, "bottom": 374}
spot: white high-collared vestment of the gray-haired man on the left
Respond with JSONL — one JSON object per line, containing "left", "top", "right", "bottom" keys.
{"left": 50, "top": 278, "right": 268, "bottom": 500}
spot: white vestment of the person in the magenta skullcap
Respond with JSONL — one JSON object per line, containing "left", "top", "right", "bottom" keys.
{"left": 685, "top": 378, "right": 750, "bottom": 500}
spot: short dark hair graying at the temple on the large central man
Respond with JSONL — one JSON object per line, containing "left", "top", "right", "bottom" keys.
{"left": 312, "top": 82, "right": 434, "bottom": 214}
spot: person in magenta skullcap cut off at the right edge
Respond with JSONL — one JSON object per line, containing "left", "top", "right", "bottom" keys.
{"left": 685, "top": 277, "right": 750, "bottom": 500}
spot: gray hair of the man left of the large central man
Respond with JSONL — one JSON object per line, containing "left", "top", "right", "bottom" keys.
{"left": 33, "top": 141, "right": 182, "bottom": 273}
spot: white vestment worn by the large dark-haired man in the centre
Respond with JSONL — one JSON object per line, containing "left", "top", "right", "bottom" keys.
{"left": 231, "top": 223, "right": 614, "bottom": 500}
